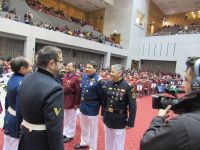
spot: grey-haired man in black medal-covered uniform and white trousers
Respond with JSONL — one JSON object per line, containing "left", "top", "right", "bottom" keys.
{"left": 102, "top": 64, "right": 136, "bottom": 150}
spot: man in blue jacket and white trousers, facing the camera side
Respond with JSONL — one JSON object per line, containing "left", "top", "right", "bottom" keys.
{"left": 74, "top": 61, "right": 103, "bottom": 149}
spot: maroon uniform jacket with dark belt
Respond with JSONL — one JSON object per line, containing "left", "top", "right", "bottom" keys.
{"left": 62, "top": 73, "right": 81, "bottom": 109}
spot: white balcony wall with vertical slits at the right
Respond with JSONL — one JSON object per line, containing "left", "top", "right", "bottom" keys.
{"left": 141, "top": 34, "right": 200, "bottom": 75}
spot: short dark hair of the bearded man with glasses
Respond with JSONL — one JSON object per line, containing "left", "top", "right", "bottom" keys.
{"left": 36, "top": 46, "right": 62, "bottom": 68}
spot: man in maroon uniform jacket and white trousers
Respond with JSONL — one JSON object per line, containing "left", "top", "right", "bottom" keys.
{"left": 62, "top": 63, "right": 81, "bottom": 143}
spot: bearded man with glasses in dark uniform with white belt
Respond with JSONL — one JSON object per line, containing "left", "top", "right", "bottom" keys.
{"left": 18, "top": 46, "right": 64, "bottom": 150}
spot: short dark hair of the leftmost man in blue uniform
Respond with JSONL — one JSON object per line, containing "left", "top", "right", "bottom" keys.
{"left": 10, "top": 56, "right": 29, "bottom": 73}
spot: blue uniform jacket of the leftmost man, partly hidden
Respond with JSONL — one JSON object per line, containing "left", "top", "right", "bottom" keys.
{"left": 4, "top": 73, "right": 24, "bottom": 138}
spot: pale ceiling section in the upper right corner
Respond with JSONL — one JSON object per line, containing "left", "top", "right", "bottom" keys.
{"left": 153, "top": 0, "right": 200, "bottom": 15}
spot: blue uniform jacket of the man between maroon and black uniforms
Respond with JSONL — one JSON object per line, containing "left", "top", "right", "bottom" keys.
{"left": 80, "top": 73, "right": 104, "bottom": 116}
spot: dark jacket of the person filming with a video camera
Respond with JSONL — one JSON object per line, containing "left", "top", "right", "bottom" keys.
{"left": 140, "top": 91, "right": 200, "bottom": 150}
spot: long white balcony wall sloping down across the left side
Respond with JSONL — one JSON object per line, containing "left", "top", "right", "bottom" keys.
{"left": 0, "top": 18, "right": 128, "bottom": 66}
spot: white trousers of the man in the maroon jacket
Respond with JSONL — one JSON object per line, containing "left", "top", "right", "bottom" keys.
{"left": 63, "top": 109, "right": 76, "bottom": 138}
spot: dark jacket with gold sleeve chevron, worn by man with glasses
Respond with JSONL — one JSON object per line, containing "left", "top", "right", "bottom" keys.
{"left": 18, "top": 68, "right": 64, "bottom": 150}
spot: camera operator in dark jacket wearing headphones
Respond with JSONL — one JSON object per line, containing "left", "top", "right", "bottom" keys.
{"left": 140, "top": 57, "right": 200, "bottom": 150}
